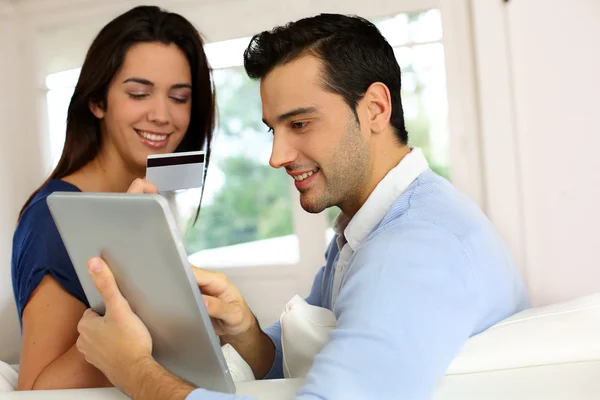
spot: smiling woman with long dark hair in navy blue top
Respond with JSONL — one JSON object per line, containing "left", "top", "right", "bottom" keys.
{"left": 12, "top": 6, "right": 215, "bottom": 390}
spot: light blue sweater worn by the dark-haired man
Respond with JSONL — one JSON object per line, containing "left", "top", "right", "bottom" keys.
{"left": 187, "top": 170, "right": 529, "bottom": 400}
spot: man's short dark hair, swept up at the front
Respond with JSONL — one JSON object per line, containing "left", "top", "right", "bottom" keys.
{"left": 244, "top": 14, "right": 408, "bottom": 144}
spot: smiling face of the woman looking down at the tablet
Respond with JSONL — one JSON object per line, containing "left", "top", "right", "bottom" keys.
{"left": 90, "top": 42, "right": 192, "bottom": 169}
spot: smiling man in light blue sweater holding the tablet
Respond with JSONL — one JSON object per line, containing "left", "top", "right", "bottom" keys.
{"left": 78, "top": 15, "right": 529, "bottom": 400}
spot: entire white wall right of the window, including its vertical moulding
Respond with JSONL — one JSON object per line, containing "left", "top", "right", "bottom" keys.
{"left": 471, "top": 0, "right": 600, "bottom": 305}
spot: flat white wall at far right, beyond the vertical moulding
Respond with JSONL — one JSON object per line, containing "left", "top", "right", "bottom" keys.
{"left": 507, "top": 0, "right": 600, "bottom": 304}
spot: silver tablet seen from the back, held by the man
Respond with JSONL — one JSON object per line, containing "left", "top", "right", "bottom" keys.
{"left": 47, "top": 192, "right": 235, "bottom": 393}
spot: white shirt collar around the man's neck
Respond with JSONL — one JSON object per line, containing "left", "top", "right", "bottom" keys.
{"left": 333, "top": 147, "right": 429, "bottom": 251}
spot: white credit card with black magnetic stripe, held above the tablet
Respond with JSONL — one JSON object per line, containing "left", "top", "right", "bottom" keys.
{"left": 146, "top": 151, "right": 205, "bottom": 192}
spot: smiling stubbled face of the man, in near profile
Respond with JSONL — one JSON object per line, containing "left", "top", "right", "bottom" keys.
{"left": 260, "top": 56, "right": 371, "bottom": 213}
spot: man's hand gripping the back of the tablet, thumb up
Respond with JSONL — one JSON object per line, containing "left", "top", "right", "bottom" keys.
{"left": 77, "top": 258, "right": 152, "bottom": 389}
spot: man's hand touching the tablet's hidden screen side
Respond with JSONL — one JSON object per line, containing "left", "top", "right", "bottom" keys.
{"left": 192, "top": 267, "right": 256, "bottom": 336}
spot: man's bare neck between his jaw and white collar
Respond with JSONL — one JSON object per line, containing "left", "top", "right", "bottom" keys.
{"left": 339, "top": 144, "right": 411, "bottom": 219}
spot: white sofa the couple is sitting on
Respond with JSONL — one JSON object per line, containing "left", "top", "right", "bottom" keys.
{"left": 0, "top": 293, "right": 600, "bottom": 400}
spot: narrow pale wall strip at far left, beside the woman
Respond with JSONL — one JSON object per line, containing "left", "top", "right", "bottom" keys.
{"left": 0, "top": 3, "right": 47, "bottom": 362}
